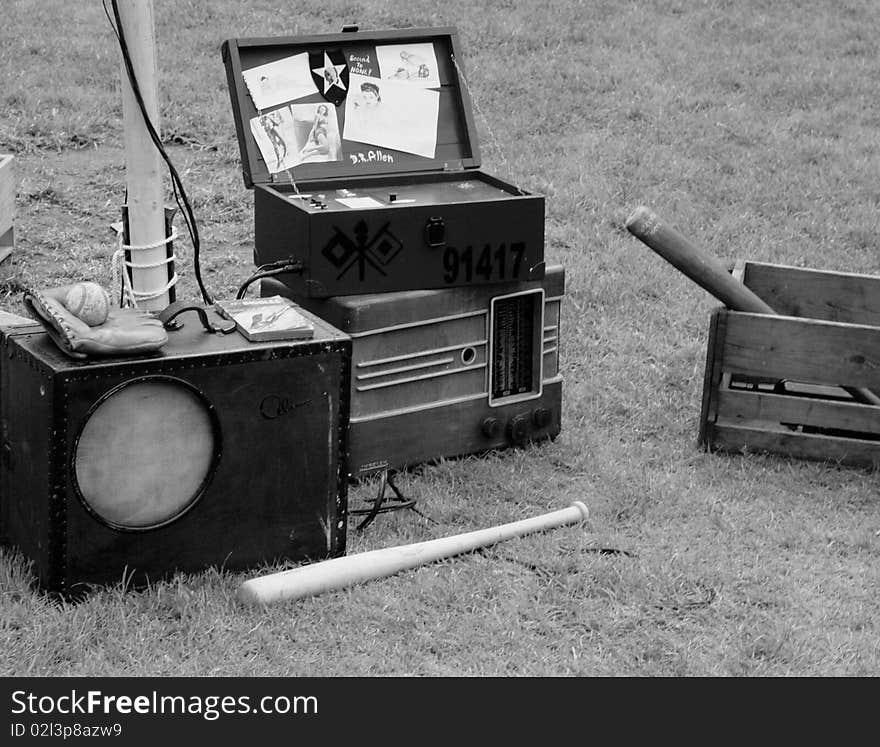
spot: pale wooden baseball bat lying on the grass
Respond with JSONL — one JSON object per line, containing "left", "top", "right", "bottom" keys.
{"left": 237, "top": 501, "right": 589, "bottom": 604}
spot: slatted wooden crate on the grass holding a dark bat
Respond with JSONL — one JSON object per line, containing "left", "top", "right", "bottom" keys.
{"left": 699, "top": 262, "right": 880, "bottom": 467}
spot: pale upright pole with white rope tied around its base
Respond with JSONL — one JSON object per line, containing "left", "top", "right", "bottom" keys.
{"left": 117, "top": 0, "right": 169, "bottom": 311}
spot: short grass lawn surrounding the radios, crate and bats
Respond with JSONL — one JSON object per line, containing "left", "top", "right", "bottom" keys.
{"left": 0, "top": 0, "right": 880, "bottom": 676}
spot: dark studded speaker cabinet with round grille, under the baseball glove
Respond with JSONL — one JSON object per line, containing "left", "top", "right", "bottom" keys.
{"left": 0, "top": 306, "right": 351, "bottom": 592}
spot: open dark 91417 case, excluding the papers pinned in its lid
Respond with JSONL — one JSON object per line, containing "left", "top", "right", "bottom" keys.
{"left": 223, "top": 27, "right": 544, "bottom": 298}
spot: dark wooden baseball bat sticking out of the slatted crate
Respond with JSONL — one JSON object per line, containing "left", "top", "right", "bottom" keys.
{"left": 626, "top": 206, "right": 880, "bottom": 405}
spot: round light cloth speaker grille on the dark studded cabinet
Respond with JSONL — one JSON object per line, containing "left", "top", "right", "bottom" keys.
{"left": 73, "top": 377, "right": 220, "bottom": 530}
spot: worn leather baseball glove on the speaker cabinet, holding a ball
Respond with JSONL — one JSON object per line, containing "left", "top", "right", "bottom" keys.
{"left": 24, "top": 285, "right": 168, "bottom": 358}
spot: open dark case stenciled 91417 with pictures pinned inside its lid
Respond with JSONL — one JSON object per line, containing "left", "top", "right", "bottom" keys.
{"left": 223, "top": 28, "right": 544, "bottom": 298}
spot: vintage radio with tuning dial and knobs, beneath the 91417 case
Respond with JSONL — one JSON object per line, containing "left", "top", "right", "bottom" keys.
{"left": 261, "top": 266, "right": 565, "bottom": 477}
